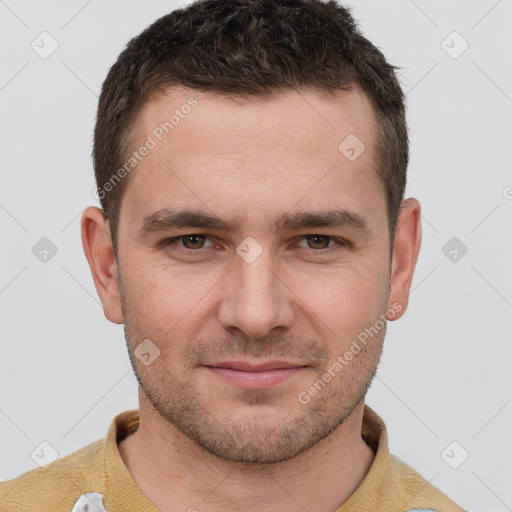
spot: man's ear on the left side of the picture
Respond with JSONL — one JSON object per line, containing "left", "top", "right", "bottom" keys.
{"left": 81, "top": 206, "right": 124, "bottom": 324}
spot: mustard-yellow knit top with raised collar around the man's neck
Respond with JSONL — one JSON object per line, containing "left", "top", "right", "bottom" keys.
{"left": 0, "top": 405, "right": 465, "bottom": 512}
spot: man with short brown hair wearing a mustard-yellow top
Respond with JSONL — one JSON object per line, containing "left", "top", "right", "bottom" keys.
{"left": 0, "top": 0, "right": 463, "bottom": 512}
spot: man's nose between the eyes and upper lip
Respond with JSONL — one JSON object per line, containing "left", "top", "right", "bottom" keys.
{"left": 218, "top": 250, "right": 295, "bottom": 339}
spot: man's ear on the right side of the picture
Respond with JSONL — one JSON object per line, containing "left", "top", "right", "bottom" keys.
{"left": 388, "top": 197, "right": 421, "bottom": 320}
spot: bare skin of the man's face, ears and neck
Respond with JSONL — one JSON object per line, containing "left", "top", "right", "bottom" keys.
{"left": 82, "top": 88, "right": 421, "bottom": 511}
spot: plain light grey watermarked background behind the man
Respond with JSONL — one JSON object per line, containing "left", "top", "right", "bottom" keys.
{"left": 0, "top": 0, "right": 512, "bottom": 512}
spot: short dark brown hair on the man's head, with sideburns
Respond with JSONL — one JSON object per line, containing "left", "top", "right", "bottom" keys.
{"left": 92, "top": 0, "right": 409, "bottom": 256}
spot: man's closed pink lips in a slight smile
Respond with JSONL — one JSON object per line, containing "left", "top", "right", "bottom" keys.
{"left": 204, "top": 361, "right": 308, "bottom": 390}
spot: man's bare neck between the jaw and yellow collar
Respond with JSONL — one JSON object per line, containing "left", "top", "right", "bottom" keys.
{"left": 119, "top": 393, "right": 375, "bottom": 512}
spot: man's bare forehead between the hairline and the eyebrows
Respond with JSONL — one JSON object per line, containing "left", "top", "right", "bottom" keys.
{"left": 123, "top": 87, "right": 383, "bottom": 227}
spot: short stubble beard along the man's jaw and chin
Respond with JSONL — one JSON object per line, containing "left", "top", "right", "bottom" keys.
{"left": 120, "top": 272, "right": 386, "bottom": 464}
